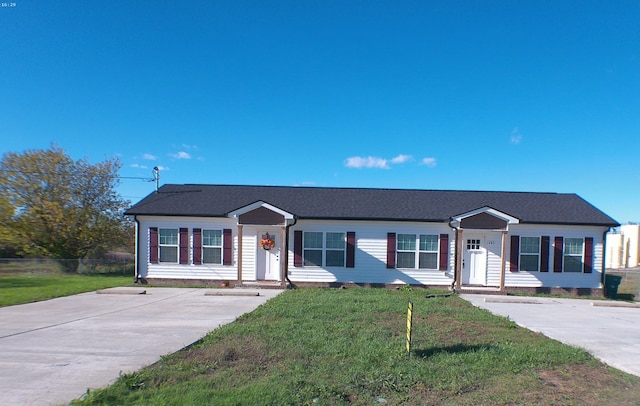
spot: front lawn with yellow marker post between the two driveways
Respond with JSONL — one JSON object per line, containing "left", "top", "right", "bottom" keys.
{"left": 74, "top": 288, "right": 640, "bottom": 405}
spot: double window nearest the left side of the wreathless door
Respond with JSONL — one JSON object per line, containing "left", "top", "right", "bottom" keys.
{"left": 396, "top": 234, "right": 438, "bottom": 269}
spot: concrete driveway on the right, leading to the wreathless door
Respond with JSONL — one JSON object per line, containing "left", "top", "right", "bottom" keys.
{"left": 460, "top": 295, "right": 640, "bottom": 376}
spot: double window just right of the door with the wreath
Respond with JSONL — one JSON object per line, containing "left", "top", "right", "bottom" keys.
{"left": 302, "top": 231, "right": 346, "bottom": 266}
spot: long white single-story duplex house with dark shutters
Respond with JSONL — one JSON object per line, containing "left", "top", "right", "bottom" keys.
{"left": 126, "top": 184, "right": 619, "bottom": 294}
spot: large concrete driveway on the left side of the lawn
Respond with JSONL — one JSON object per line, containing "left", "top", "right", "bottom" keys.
{"left": 0, "top": 288, "right": 281, "bottom": 406}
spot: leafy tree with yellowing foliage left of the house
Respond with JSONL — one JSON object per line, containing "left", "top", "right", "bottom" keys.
{"left": 0, "top": 145, "right": 130, "bottom": 271}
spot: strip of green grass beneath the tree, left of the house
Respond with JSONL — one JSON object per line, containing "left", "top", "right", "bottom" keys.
{"left": 0, "top": 263, "right": 132, "bottom": 307}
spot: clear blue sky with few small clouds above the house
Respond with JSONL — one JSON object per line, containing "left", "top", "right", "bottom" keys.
{"left": 0, "top": 0, "right": 640, "bottom": 223}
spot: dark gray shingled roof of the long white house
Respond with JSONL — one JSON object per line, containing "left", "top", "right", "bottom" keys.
{"left": 126, "top": 184, "right": 619, "bottom": 227}
